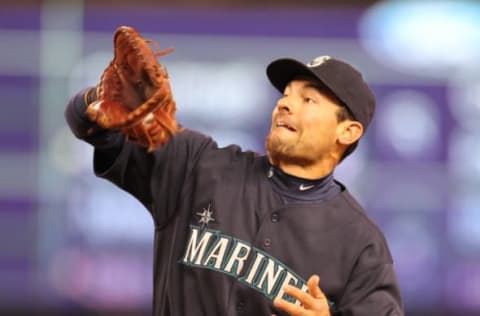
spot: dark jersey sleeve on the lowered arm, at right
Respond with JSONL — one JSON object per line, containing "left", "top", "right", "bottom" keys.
{"left": 332, "top": 235, "right": 404, "bottom": 316}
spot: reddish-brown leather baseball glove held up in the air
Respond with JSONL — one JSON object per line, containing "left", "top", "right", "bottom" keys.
{"left": 86, "top": 26, "right": 179, "bottom": 152}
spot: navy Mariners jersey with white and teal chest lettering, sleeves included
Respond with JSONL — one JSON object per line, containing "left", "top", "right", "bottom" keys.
{"left": 66, "top": 90, "right": 403, "bottom": 316}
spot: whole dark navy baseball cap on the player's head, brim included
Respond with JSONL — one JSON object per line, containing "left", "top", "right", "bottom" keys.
{"left": 267, "top": 56, "right": 375, "bottom": 130}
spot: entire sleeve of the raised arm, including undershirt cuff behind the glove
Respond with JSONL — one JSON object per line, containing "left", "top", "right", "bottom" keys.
{"left": 65, "top": 90, "right": 217, "bottom": 225}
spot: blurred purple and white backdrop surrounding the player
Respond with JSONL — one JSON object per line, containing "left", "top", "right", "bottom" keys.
{"left": 0, "top": 0, "right": 480, "bottom": 315}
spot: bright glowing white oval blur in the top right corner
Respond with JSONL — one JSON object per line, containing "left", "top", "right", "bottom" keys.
{"left": 360, "top": 0, "right": 480, "bottom": 79}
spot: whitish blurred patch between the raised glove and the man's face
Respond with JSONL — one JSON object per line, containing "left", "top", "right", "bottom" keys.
{"left": 172, "top": 60, "right": 273, "bottom": 152}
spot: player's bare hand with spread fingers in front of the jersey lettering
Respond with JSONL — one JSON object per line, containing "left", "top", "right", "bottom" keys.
{"left": 273, "top": 274, "right": 330, "bottom": 316}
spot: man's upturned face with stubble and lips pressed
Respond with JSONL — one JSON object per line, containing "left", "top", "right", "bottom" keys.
{"left": 266, "top": 78, "right": 339, "bottom": 165}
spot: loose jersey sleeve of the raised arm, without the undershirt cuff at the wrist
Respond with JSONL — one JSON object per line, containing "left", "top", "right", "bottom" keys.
{"left": 93, "top": 129, "right": 217, "bottom": 226}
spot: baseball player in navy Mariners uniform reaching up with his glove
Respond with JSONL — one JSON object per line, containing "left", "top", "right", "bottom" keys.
{"left": 65, "top": 30, "right": 404, "bottom": 316}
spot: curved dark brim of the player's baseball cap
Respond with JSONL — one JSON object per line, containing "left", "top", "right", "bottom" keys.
{"left": 267, "top": 58, "right": 321, "bottom": 92}
